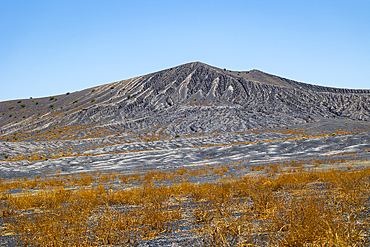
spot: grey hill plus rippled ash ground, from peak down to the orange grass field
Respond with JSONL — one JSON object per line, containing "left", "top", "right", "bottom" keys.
{"left": 0, "top": 62, "right": 370, "bottom": 177}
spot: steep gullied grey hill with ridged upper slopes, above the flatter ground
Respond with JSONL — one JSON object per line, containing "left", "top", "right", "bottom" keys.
{"left": 0, "top": 62, "right": 370, "bottom": 139}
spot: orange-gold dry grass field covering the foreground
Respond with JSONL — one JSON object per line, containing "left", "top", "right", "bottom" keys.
{"left": 0, "top": 166, "right": 370, "bottom": 246}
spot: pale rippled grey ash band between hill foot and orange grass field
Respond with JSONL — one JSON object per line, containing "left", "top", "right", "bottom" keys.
{"left": 0, "top": 118, "right": 370, "bottom": 178}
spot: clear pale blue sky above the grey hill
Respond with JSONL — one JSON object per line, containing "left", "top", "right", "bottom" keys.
{"left": 0, "top": 0, "right": 370, "bottom": 101}
